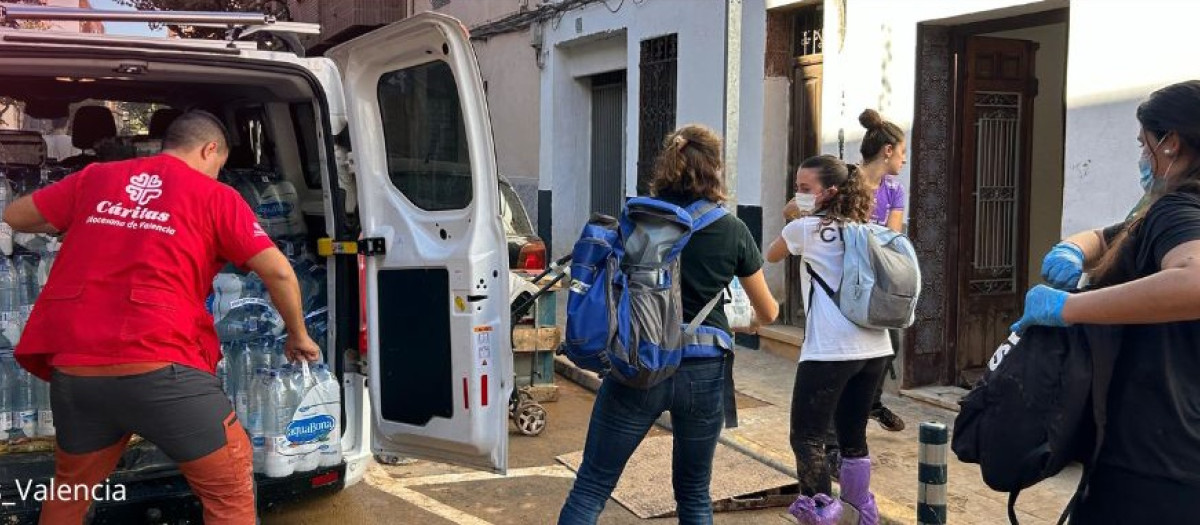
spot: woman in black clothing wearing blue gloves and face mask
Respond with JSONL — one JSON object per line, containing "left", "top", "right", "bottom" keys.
{"left": 1014, "top": 80, "right": 1200, "bottom": 524}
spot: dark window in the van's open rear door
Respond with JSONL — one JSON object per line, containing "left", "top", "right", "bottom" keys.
{"left": 378, "top": 61, "right": 474, "bottom": 211}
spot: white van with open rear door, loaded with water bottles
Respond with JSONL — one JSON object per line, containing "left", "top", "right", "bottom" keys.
{"left": 0, "top": 5, "right": 512, "bottom": 523}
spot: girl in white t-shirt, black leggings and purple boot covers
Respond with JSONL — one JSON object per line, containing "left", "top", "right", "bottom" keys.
{"left": 767, "top": 155, "right": 893, "bottom": 525}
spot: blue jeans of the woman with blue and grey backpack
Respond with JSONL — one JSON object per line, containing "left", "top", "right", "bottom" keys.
{"left": 558, "top": 357, "right": 725, "bottom": 525}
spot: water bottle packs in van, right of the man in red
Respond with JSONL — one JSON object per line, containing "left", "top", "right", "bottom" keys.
{"left": 208, "top": 169, "right": 342, "bottom": 477}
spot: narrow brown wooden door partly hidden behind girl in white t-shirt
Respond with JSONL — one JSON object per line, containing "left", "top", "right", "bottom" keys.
{"left": 779, "top": 55, "right": 822, "bottom": 325}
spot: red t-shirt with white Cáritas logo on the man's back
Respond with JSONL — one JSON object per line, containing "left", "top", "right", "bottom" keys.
{"left": 16, "top": 155, "right": 275, "bottom": 379}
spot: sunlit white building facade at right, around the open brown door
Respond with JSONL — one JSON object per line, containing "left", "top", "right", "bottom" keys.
{"left": 743, "top": 0, "right": 1200, "bottom": 386}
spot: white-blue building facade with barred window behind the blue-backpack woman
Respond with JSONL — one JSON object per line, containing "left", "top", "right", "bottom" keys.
{"left": 535, "top": 0, "right": 766, "bottom": 260}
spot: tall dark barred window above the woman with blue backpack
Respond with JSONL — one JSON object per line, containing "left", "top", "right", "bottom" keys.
{"left": 637, "top": 34, "right": 679, "bottom": 195}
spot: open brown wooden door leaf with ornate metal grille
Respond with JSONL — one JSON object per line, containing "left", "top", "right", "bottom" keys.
{"left": 955, "top": 37, "right": 1037, "bottom": 386}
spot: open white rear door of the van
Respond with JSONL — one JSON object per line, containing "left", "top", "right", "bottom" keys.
{"left": 328, "top": 13, "right": 512, "bottom": 473}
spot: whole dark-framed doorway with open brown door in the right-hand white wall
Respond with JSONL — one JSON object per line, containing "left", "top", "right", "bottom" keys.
{"left": 901, "top": 7, "right": 1069, "bottom": 388}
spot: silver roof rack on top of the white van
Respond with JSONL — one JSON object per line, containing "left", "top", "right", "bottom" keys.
{"left": 0, "top": 5, "right": 320, "bottom": 56}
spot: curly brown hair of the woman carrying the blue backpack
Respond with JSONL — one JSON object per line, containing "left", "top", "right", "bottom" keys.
{"left": 650, "top": 125, "right": 726, "bottom": 203}
